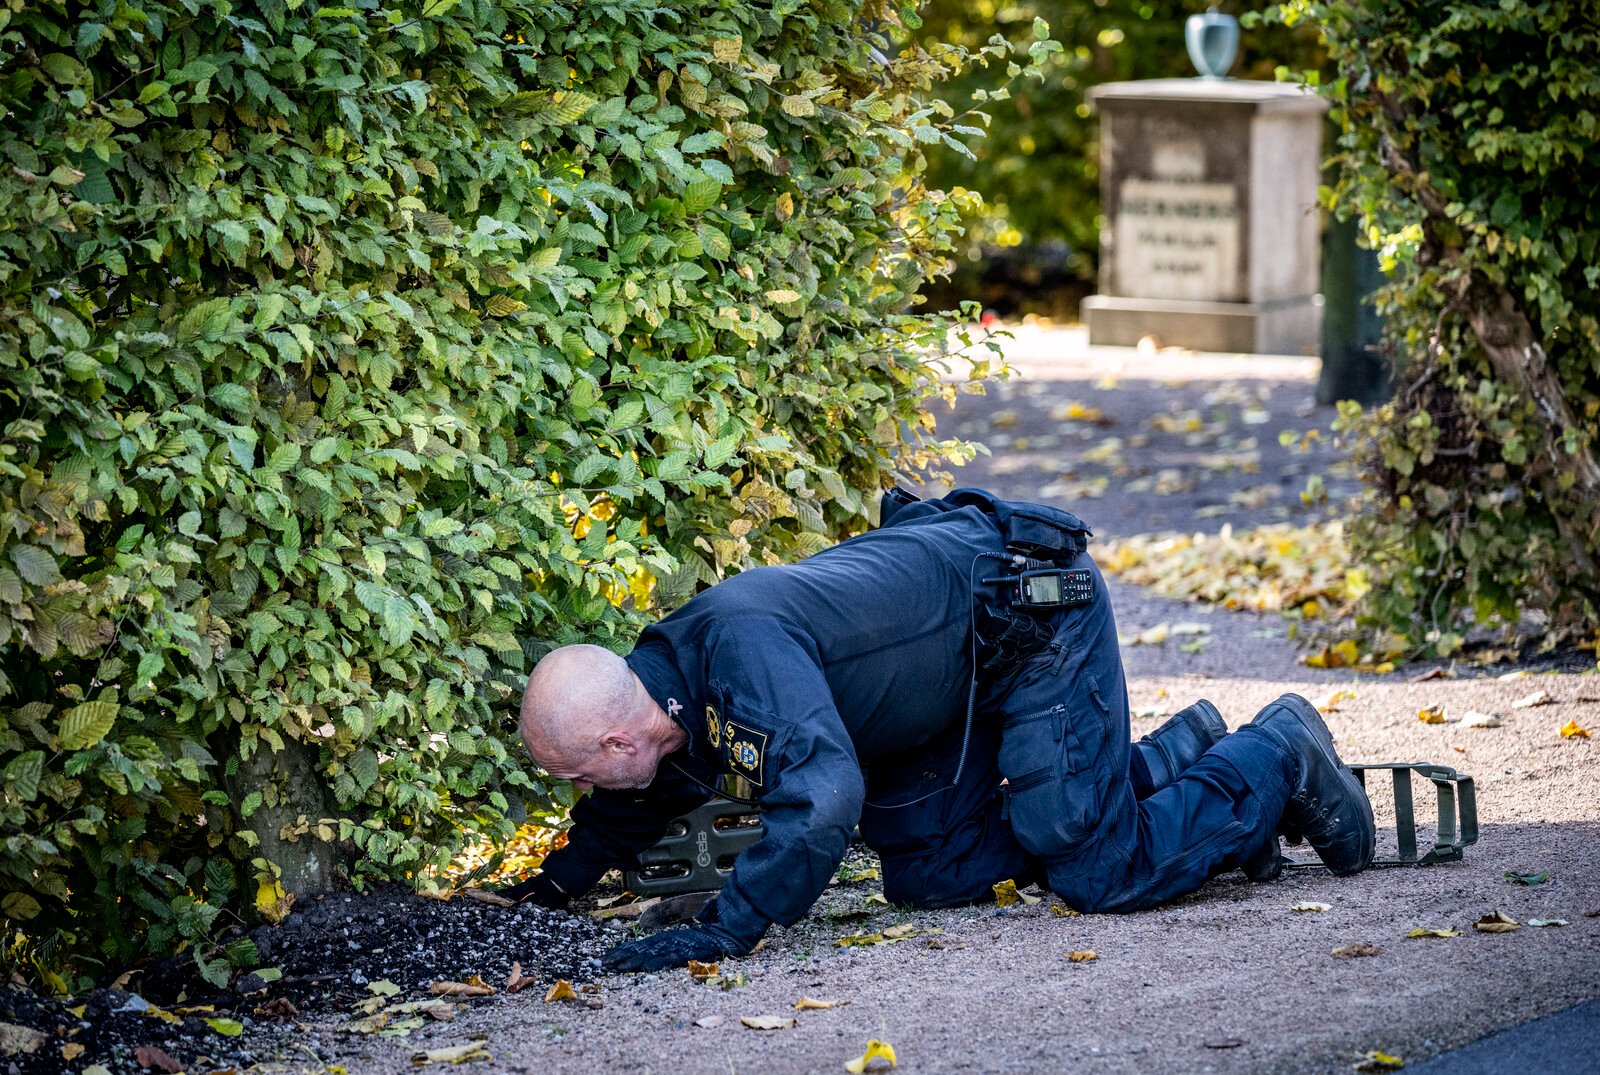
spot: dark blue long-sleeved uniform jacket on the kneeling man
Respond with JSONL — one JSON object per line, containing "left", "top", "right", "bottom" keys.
{"left": 546, "top": 502, "right": 1003, "bottom": 942}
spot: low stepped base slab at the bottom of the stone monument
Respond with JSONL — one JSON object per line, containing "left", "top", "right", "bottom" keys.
{"left": 1083, "top": 294, "right": 1322, "bottom": 355}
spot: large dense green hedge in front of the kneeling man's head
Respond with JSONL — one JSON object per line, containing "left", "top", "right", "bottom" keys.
{"left": 0, "top": 0, "right": 1048, "bottom": 989}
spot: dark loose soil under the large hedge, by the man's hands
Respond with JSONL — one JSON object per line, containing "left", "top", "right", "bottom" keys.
{"left": 0, "top": 886, "right": 626, "bottom": 1075}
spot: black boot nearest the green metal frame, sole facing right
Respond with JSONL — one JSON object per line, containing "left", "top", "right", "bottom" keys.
{"left": 1243, "top": 694, "right": 1378, "bottom": 881}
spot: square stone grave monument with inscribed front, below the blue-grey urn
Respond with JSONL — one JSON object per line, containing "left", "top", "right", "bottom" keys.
{"left": 1083, "top": 78, "right": 1328, "bottom": 355}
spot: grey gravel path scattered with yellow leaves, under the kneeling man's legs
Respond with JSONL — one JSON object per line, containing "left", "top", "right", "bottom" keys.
{"left": 317, "top": 331, "right": 1600, "bottom": 1075}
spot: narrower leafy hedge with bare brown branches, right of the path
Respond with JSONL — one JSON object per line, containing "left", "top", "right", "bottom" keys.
{"left": 1280, "top": 0, "right": 1600, "bottom": 654}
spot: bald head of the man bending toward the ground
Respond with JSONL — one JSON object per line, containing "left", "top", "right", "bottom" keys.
{"left": 522, "top": 645, "right": 686, "bottom": 790}
